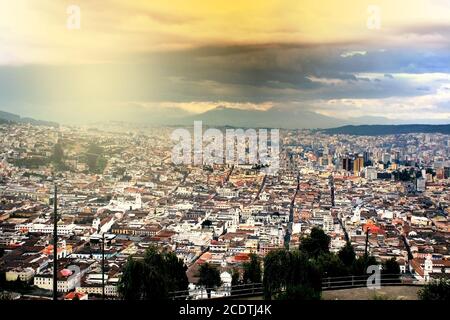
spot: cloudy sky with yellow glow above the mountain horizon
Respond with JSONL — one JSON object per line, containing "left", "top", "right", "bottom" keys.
{"left": 0, "top": 0, "right": 450, "bottom": 123}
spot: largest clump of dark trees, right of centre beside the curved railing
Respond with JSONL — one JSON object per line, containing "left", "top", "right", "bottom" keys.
{"left": 263, "top": 228, "right": 384, "bottom": 300}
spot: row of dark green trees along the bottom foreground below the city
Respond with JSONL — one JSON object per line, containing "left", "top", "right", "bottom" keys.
{"left": 119, "top": 228, "right": 400, "bottom": 300}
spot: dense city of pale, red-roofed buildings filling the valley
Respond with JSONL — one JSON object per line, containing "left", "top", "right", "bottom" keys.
{"left": 0, "top": 123, "right": 450, "bottom": 300}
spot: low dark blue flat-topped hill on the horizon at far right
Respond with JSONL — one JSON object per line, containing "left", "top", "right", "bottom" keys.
{"left": 321, "top": 124, "right": 450, "bottom": 136}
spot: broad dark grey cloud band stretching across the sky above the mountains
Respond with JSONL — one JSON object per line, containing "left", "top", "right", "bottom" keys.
{"left": 0, "top": 40, "right": 450, "bottom": 104}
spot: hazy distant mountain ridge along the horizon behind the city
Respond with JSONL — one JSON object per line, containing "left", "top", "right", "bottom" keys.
{"left": 0, "top": 105, "right": 450, "bottom": 135}
